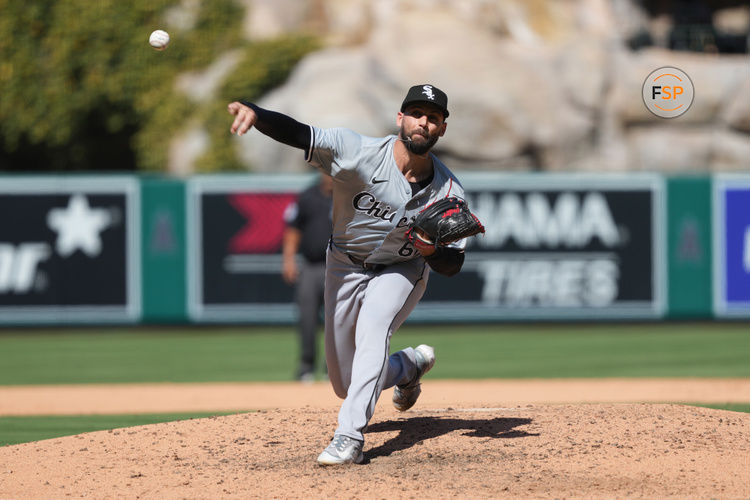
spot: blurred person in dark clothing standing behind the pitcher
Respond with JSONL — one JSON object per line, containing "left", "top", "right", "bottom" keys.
{"left": 282, "top": 175, "right": 333, "bottom": 382}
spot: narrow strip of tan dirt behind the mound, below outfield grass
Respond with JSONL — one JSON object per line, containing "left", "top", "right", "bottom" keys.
{"left": 0, "top": 378, "right": 750, "bottom": 416}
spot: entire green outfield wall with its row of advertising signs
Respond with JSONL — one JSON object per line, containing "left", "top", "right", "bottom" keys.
{"left": 0, "top": 172, "right": 750, "bottom": 324}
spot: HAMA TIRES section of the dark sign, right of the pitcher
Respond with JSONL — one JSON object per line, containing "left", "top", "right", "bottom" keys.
{"left": 412, "top": 174, "right": 665, "bottom": 321}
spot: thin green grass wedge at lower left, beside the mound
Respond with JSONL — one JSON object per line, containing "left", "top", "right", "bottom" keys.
{"left": 0, "top": 412, "right": 239, "bottom": 446}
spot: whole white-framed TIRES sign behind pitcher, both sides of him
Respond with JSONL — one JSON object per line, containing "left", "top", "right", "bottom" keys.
{"left": 187, "top": 173, "right": 666, "bottom": 323}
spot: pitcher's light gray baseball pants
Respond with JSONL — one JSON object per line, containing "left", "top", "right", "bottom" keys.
{"left": 325, "top": 244, "right": 429, "bottom": 441}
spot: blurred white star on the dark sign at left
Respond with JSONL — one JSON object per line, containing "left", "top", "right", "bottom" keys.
{"left": 47, "top": 194, "right": 112, "bottom": 257}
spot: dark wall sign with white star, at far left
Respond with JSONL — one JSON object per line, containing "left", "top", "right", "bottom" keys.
{"left": 0, "top": 176, "right": 140, "bottom": 323}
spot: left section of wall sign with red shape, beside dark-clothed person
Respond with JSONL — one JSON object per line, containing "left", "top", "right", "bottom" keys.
{"left": 187, "top": 175, "right": 315, "bottom": 323}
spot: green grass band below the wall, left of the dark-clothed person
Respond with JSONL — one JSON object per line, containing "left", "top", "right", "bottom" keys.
{"left": 0, "top": 328, "right": 298, "bottom": 385}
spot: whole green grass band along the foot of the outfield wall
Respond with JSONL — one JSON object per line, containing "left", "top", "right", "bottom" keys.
{"left": 0, "top": 323, "right": 750, "bottom": 385}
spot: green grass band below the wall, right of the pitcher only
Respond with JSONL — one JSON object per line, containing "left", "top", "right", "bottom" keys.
{"left": 408, "top": 324, "right": 750, "bottom": 378}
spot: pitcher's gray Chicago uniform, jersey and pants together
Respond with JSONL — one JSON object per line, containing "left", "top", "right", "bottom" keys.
{"left": 307, "top": 127, "right": 465, "bottom": 441}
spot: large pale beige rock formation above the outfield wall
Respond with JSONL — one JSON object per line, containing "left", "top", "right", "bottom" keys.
{"left": 184, "top": 0, "right": 750, "bottom": 172}
